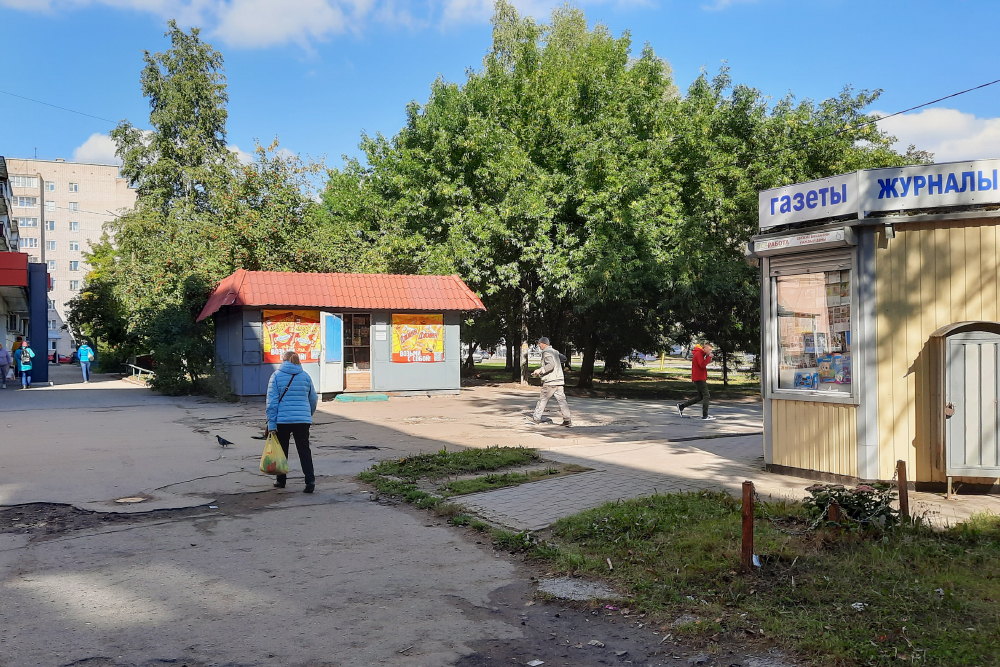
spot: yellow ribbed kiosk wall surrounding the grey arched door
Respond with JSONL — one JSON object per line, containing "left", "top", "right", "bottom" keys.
{"left": 875, "top": 219, "right": 1000, "bottom": 482}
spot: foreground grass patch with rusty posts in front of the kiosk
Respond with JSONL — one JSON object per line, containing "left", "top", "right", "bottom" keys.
{"left": 536, "top": 492, "right": 1000, "bottom": 667}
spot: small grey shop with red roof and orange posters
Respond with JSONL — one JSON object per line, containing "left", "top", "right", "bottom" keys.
{"left": 197, "top": 269, "right": 486, "bottom": 396}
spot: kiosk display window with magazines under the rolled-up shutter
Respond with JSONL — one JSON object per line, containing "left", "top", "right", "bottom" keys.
{"left": 775, "top": 271, "right": 852, "bottom": 393}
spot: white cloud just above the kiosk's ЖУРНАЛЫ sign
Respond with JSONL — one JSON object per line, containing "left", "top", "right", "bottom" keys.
{"left": 875, "top": 109, "right": 1000, "bottom": 162}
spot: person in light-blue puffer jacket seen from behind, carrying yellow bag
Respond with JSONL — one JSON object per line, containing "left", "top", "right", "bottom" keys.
{"left": 267, "top": 352, "right": 319, "bottom": 493}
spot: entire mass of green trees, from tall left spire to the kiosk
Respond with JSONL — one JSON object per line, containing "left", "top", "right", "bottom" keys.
{"left": 70, "top": 0, "right": 931, "bottom": 391}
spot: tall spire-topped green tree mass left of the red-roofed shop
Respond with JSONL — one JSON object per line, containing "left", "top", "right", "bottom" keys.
{"left": 71, "top": 22, "right": 326, "bottom": 393}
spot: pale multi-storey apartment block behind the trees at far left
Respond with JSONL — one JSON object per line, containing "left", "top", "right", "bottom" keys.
{"left": 7, "top": 158, "right": 135, "bottom": 355}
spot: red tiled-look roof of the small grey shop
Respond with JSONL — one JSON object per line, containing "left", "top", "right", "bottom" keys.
{"left": 198, "top": 269, "right": 486, "bottom": 321}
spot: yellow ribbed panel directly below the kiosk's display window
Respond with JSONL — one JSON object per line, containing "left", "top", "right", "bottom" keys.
{"left": 771, "top": 400, "right": 858, "bottom": 477}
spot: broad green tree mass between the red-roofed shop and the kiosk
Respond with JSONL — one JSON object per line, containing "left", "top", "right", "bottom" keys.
{"left": 317, "top": 0, "right": 927, "bottom": 385}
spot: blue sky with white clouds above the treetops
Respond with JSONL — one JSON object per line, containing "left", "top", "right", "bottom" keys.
{"left": 0, "top": 0, "right": 1000, "bottom": 166}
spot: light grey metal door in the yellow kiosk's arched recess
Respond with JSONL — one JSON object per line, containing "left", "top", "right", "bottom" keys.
{"left": 945, "top": 332, "right": 1000, "bottom": 478}
